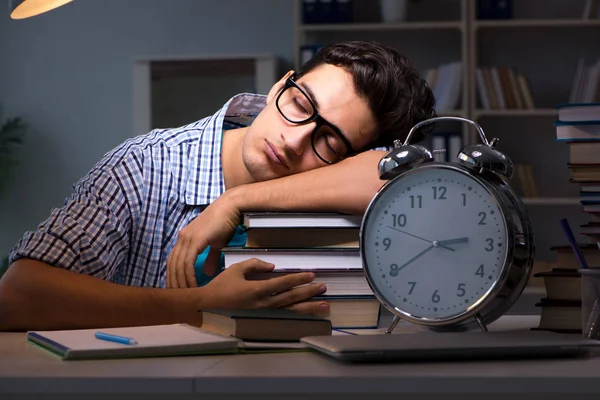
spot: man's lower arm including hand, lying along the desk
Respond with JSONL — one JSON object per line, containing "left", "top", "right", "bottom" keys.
{"left": 0, "top": 259, "right": 328, "bottom": 331}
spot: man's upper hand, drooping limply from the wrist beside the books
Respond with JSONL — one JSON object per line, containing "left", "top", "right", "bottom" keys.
{"left": 167, "top": 194, "right": 241, "bottom": 288}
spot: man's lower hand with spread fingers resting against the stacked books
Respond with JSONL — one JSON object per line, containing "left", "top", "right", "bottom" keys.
{"left": 201, "top": 258, "right": 329, "bottom": 317}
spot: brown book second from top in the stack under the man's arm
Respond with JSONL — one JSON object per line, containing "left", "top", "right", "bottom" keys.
{"left": 246, "top": 228, "right": 360, "bottom": 249}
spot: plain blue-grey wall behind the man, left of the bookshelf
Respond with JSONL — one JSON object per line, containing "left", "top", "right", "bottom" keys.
{"left": 0, "top": 0, "right": 293, "bottom": 258}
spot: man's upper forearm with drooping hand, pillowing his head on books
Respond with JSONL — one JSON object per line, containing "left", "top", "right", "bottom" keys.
{"left": 167, "top": 151, "right": 386, "bottom": 288}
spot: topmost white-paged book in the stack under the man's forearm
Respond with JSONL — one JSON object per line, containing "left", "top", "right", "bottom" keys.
{"left": 243, "top": 212, "right": 362, "bottom": 228}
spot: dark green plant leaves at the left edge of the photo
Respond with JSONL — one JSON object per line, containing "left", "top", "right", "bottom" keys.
{"left": 0, "top": 111, "right": 27, "bottom": 196}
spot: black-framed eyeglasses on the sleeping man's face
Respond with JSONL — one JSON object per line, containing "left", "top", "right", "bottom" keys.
{"left": 275, "top": 76, "right": 356, "bottom": 164}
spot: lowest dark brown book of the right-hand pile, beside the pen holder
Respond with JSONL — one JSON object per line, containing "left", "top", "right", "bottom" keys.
{"left": 534, "top": 298, "right": 581, "bottom": 333}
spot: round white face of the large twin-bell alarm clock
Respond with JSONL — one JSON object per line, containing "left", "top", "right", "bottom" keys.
{"left": 361, "top": 165, "right": 508, "bottom": 321}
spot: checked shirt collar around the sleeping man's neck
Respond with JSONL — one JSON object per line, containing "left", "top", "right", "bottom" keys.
{"left": 185, "top": 93, "right": 267, "bottom": 206}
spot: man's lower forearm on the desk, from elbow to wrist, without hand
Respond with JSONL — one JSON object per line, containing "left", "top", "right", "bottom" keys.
{"left": 0, "top": 259, "right": 201, "bottom": 330}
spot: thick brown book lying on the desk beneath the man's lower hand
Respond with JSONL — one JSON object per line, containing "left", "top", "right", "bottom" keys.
{"left": 202, "top": 308, "right": 331, "bottom": 341}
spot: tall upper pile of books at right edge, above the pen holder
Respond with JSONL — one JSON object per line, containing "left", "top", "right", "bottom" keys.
{"left": 555, "top": 103, "right": 600, "bottom": 243}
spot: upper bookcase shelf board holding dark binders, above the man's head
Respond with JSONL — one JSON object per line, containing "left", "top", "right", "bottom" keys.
{"left": 299, "top": 21, "right": 463, "bottom": 32}
